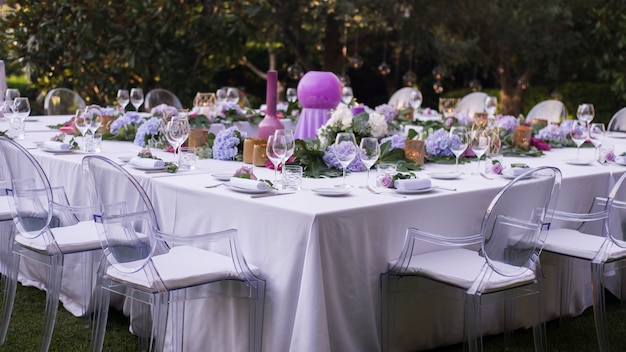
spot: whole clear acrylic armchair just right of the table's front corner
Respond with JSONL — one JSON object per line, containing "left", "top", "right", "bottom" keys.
{"left": 381, "top": 167, "right": 561, "bottom": 351}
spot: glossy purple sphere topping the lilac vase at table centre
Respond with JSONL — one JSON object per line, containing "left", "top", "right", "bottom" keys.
{"left": 298, "top": 71, "right": 341, "bottom": 109}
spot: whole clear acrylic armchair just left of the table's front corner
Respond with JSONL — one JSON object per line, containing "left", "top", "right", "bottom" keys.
{"left": 83, "top": 156, "right": 265, "bottom": 351}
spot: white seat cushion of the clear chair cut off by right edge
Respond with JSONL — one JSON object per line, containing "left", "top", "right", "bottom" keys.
{"left": 543, "top": 228, "right": 626, "bottom": 261}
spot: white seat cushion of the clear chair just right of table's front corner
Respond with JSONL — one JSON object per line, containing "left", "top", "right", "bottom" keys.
{"left": 389, "top": 248, "right": 535, "bottom": 292}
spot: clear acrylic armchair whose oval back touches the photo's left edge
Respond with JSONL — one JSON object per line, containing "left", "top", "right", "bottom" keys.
{"left": 0, "top": 137, "right": 102, "bottom": 351}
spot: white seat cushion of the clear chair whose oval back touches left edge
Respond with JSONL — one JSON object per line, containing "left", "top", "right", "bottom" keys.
{"left": 15, "top": 221, "right": 102, "bottom": 253}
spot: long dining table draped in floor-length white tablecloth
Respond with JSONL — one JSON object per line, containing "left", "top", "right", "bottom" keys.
{"left": 0, "top": 116, "right": 626, "bottom": 352}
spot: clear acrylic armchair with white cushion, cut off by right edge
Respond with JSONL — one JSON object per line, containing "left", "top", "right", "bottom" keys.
{"left": 544, "top": 174, "right": 626, "bottom": 351}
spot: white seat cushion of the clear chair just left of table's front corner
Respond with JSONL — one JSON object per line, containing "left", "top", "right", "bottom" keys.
{"left": 107, "top": 246, "right": 258, "bottom": 290}
